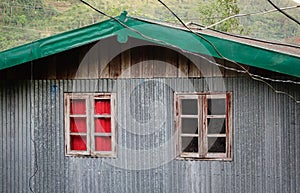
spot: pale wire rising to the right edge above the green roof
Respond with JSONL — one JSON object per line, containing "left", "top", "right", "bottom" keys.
{"left": 202, "top": 5, "right": 300, "bottom": 29}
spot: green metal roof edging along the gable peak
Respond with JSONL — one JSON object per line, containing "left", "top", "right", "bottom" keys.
{"left": 0, "top": 12, "right": 300, "bottom": 77}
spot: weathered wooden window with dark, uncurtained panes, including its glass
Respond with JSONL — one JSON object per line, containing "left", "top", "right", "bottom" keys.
{"left": 175, "top": 93, "right": 233, "bottom": 160}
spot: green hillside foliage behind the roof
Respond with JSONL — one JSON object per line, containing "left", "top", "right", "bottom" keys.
{"left": 0, "top": 0, "right": 300, "bottom": 50}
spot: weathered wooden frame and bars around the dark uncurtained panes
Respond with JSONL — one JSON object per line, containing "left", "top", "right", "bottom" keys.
{"left": 174, "top": 92, "right": 233, "bottom": 161}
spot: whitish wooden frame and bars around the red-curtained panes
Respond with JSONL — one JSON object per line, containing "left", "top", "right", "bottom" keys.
{"left": 64, "top": 93, "right": 117, "bottom": 157}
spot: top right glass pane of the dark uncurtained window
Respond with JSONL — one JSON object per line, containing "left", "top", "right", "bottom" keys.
{"left": 207, "top": 99, "right": 226, "bottom": 115}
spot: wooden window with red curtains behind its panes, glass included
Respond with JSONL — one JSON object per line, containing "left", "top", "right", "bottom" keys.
{"left": 65, "top": 93, "right": 116, "bottom": 157}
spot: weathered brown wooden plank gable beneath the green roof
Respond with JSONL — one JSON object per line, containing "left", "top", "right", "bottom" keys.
{"left": 0, "top": 38, "right": 274, "bottom": 79}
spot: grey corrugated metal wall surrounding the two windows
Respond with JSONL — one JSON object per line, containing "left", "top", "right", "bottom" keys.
{"left": 0, "top": 78, "right": 300, "bottom": 193}
